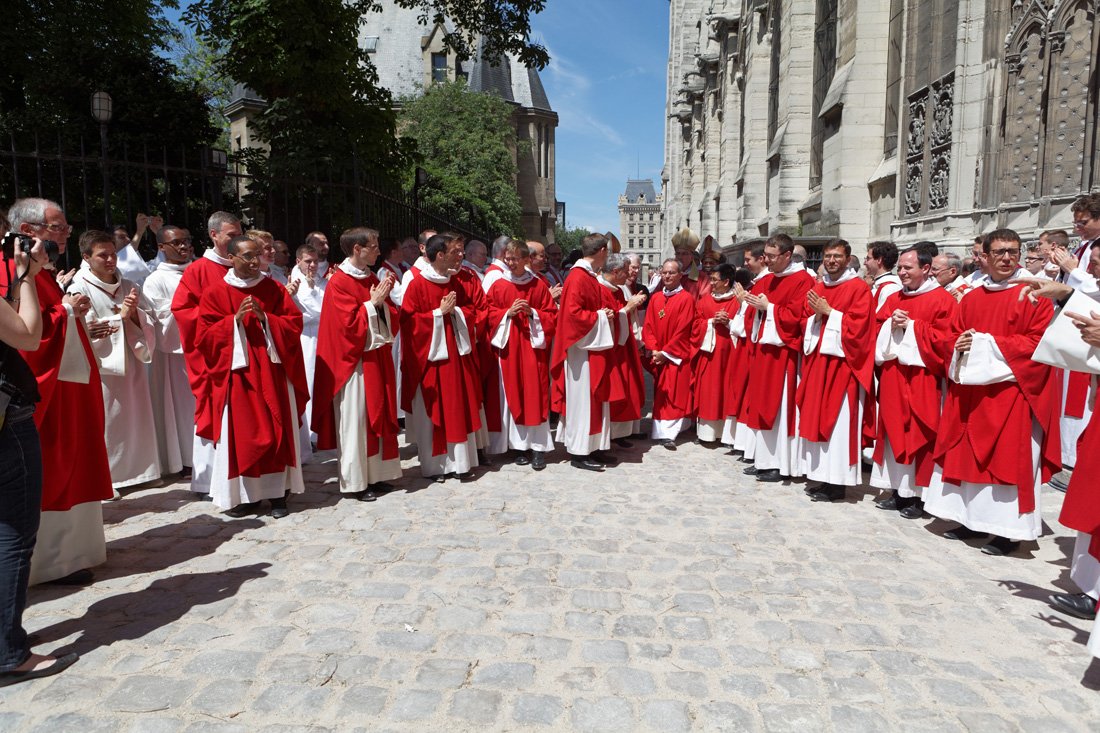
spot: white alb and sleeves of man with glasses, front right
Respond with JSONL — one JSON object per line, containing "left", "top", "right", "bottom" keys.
{"left": 923, "top": 333, "right": 1043, "bottom": 540}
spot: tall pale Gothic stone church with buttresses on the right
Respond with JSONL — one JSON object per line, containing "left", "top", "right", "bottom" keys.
{"left": 660, "top": 0, "right": 1100, "bottom": 263}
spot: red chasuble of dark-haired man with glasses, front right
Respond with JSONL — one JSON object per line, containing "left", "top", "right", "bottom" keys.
{"left": 935, "top": 286, "right": 1062, "bottom": 514}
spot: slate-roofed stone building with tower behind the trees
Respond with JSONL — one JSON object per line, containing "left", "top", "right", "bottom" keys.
{"left": 360, "top": 0, "right": 558, "bottom": 243}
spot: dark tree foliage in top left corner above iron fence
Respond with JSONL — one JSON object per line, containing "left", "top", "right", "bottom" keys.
{"left": 0, "top": 0, "right": 216, "bottom": 151}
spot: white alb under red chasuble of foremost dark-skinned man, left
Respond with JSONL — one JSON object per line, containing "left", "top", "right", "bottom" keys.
{"left": 210, "top": 270, "right": 306, "bottom": 510}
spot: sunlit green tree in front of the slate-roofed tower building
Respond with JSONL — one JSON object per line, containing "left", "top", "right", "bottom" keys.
{"left": 399, "top": 80, "right": 523, "bottom": 236}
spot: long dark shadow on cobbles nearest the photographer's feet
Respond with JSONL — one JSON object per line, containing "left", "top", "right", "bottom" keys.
{"left": 36, "top": 562, "right": 271, "bottom": 655}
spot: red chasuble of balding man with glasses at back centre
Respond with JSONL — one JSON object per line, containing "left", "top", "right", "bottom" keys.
{"left": 641, "top": 288, "right": 699, "bottom": 420}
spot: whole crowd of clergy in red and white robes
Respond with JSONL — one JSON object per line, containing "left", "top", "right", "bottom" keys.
{"left": 2, "top": 194, "right": 1100, "bottom": 656}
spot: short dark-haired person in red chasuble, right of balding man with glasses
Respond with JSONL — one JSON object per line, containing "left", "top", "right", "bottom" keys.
{"left": 692, "top": 264, "right": 741, "bottom": 446}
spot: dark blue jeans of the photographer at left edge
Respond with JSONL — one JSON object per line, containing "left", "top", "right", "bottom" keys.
{"left": 0, "top": 406, "right": 42, "bottom": 672}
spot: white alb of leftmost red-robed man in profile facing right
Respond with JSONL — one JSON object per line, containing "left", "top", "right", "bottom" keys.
{"left": 332, "top": 260, "right": 402, "bottom": 493}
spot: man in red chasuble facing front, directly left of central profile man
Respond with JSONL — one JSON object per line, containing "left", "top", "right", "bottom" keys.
{"left": 485, "top": 240, "right": 558, "bottom": 471}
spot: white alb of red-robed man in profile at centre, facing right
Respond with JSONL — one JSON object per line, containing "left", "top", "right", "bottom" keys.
{"left": 557, "top": 260, "right": 615, "bottom": 456}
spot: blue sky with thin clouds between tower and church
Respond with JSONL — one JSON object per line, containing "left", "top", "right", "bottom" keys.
{"left": 531, "top": 0, "right": 669, "bottom": 232}
